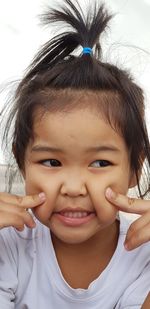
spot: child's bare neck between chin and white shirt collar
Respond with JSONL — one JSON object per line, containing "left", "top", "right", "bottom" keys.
{"left": 52, "top": 221, "right": 119, "bottom": 289}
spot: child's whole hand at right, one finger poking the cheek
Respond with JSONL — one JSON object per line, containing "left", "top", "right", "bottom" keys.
{"left": 106, "top": 188, "right": 150, "bottom": 250}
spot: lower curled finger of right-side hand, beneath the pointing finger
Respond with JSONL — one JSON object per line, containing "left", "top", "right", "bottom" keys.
{"left": 124, "top": 222, "right": 150, "bottom": 250}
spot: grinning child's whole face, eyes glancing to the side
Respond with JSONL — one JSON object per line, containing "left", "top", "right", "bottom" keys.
{"left": 25, "top": 107, "right": 135, "bottom": 243}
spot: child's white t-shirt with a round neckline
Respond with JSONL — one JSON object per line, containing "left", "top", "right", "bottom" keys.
{"left": 0, "top": 215, "right": 150, "bottom": 309}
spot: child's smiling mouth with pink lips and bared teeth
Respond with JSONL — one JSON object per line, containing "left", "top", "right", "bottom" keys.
{"left": 54, "top": 208, "right": 96, "bottom": 226}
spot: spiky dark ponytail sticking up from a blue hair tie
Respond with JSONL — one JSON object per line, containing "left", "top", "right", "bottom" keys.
{"left": 21, "top": 0, "right": 112, "bottom": 88}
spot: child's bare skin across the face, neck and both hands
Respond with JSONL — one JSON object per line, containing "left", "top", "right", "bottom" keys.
{"left": 0, "top": 103, "right": 150, "bottom": 292}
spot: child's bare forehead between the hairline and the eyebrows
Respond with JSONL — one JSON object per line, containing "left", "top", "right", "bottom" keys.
{"left": 33, "top": 106, "right": 126, "bottom": 154}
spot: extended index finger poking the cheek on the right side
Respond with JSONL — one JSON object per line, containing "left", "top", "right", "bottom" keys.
{"left": 105, "top": 188, "right": 150, "bottom": 215}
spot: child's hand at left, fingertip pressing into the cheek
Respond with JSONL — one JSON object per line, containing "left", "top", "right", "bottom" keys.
{"left": 0, "top": 192, "right": 46, "bottom": 231}
